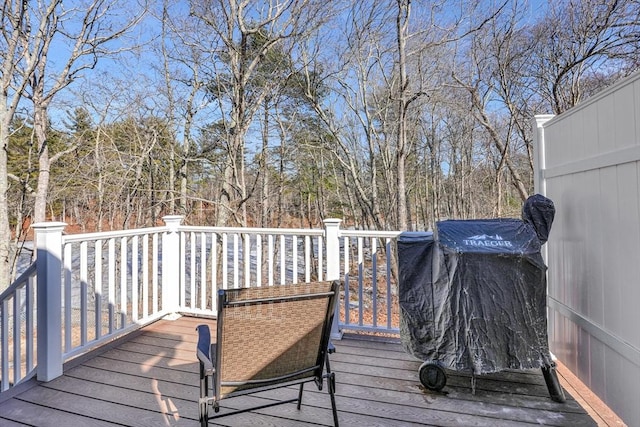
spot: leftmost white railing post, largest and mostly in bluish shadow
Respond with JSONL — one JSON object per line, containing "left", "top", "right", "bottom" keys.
{"left": 31, "top": 222, "right": 69, "bottom": 381}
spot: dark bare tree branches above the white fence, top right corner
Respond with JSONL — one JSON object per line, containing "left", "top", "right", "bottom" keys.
{"left": 530, "top": 0, "right": 640, "bottom": 114}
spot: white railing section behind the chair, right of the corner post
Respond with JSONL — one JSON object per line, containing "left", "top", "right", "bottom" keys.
{"left": 179, "top": 226, "right": 326, "bottom": 314}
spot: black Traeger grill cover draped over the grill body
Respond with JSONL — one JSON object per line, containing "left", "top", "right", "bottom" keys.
{"left": 398, "top": 219, "right": 551, "bottom": 374}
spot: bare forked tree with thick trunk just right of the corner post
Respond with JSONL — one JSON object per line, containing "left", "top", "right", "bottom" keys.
{"left": 191, "top": 0, "right": 330, "bottom": 225}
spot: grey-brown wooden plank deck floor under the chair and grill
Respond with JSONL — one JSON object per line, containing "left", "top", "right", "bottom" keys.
{"left": 0, "top": 317, "right": 601, "bottom": 427}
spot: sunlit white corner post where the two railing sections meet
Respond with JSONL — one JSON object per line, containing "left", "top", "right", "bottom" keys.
{"left": 162, "top": 215, "right": 184, "bottom": 313}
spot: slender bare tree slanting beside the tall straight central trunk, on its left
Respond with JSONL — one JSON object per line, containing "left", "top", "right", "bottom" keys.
{"left": 298, "top": 2, "right": 393, "bottom": 228}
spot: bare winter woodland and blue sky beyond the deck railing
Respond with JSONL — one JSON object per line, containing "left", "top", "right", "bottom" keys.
{"left": 0, "top": 0, "right": 640, "bottom": 289}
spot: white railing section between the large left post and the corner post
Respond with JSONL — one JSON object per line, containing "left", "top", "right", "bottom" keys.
{"left": 61, "top": 227, "right": 170, "bottom": 360}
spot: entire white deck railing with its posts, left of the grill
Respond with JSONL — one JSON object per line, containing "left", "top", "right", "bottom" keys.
{"left": 0, "top": 216, "right": 399, "bottom": 391}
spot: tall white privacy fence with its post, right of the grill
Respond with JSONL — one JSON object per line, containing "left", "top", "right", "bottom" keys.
{"left": 535, "top": 73, "right": 640, "bottom": 426}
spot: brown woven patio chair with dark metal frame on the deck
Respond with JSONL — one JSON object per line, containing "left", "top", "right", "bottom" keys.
{"left": 196, "top": 281, "right": 339, "bottom": 427}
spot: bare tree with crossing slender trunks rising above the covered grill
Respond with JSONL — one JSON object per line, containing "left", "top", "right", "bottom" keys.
{"left": 451, "top": 2, "right": 532, "bottom": 206}
